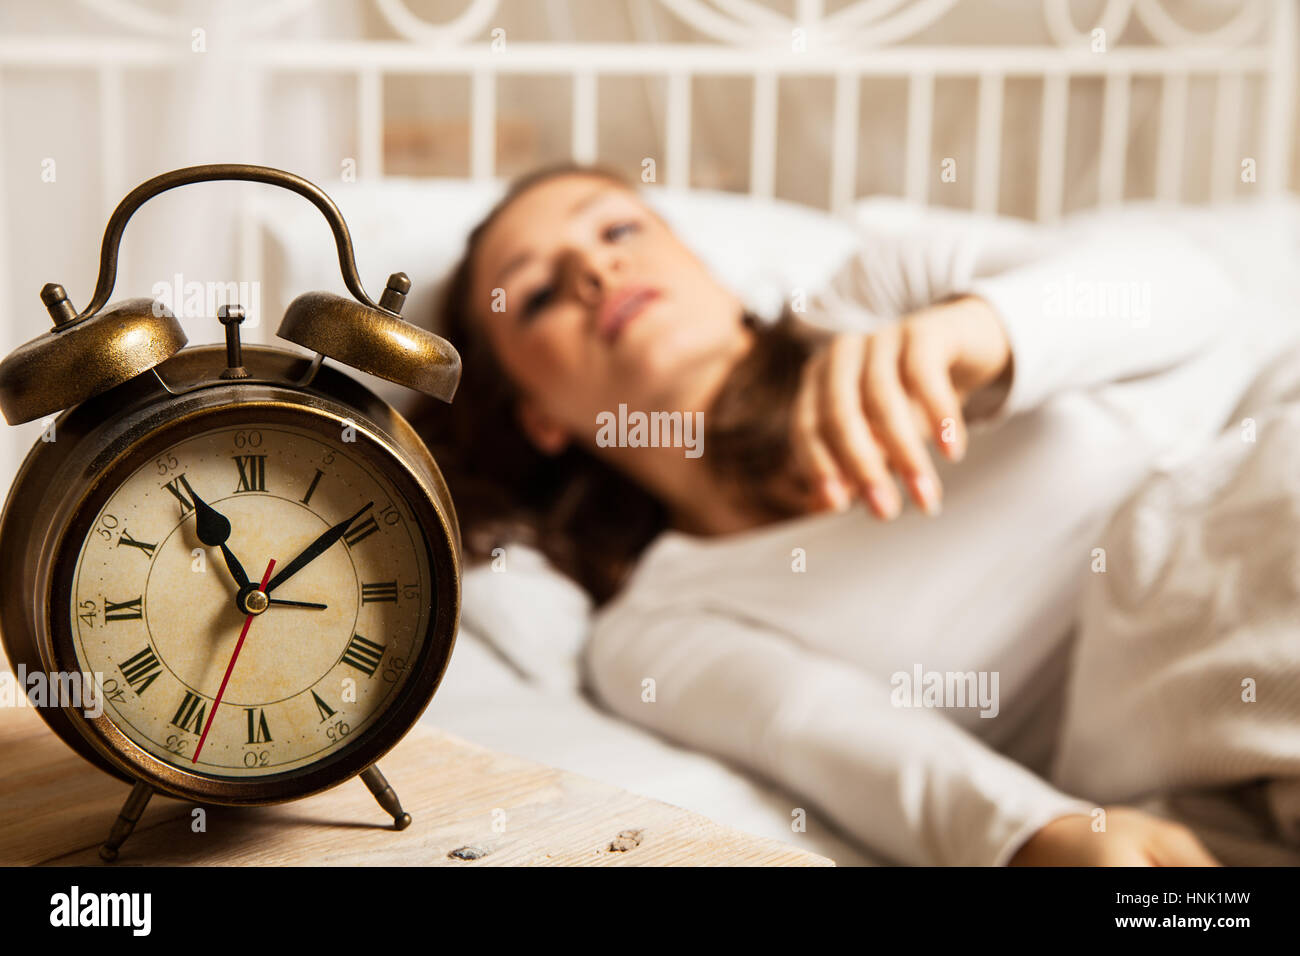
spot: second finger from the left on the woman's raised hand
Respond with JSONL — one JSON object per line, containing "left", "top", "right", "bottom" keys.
{"left": 820, "top": 336, "right": 902, "bottom": 519}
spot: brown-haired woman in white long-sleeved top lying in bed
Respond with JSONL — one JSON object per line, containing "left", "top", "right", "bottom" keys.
{"left": 417, "top": 166, "right": 1289, "bottom": 865}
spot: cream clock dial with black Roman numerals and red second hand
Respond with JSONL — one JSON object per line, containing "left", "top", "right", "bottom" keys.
{"left": 68, "top": 423, "right": 434, "bottom": 778}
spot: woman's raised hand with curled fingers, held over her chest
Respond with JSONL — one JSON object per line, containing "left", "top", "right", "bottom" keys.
{"left": 792, "top": 297, "right": 1011, "bottom": 519}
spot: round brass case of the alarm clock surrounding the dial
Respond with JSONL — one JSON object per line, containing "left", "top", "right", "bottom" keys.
{"left": 0, "top": 346, "right": 460, "bottom": 805}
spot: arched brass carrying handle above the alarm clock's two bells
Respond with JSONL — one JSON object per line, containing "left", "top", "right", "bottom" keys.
{"left": 77, "top": 163, "right": 386, "bottom": 320}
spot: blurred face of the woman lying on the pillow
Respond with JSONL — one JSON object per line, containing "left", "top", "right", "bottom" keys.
{"left": 471, "top": 173, "right": 753, "bottom": 451}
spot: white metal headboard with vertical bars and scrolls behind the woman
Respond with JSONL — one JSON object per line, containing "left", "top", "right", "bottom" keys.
{"left": 0, "top": 0, "right": 1296, "bottom": 220}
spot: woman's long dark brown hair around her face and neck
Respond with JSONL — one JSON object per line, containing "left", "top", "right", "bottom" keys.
{"left": 411, "top": 164, "right": 811, "bottom": 604}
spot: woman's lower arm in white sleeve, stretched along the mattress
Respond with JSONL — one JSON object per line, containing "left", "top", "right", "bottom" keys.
{"left": 586, "top": 611, "right": 1093, "bottom": 865}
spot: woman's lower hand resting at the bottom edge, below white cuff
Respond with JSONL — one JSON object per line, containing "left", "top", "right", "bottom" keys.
{"left": 1010, "top": 806, "right": 1222, "bottom": 866}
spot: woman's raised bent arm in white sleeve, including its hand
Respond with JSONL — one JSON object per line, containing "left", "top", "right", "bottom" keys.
{"left": 792, "top": 225, "right": 1236, "bottom": 519}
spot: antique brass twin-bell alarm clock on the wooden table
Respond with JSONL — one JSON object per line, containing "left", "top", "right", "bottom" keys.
{"left": 0, "top": 165, "right": 460, "bottom": 860}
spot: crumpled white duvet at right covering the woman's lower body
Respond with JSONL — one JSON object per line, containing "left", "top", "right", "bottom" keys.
{"left": 1053, "top": 350, "right": 1300, "bottom": 862}
